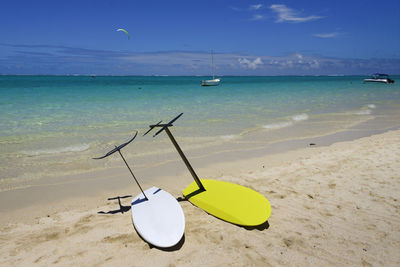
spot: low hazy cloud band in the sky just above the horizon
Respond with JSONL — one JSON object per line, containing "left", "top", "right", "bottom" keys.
{"left": 0, "top": 44, "right": 400, "bottom": 75}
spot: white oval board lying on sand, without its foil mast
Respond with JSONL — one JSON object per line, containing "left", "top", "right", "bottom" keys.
{"left": 132, "top": 187, "right": 185, "bottom": 248}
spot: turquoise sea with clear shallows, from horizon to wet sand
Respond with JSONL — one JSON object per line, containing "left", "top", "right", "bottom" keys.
{"left": 0, "top": 75, "right": 400, "bottom": 191}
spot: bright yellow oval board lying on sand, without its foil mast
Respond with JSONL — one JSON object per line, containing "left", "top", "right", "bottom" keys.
{"left": 182, "top": 179, "right": 271, "bottom": 226}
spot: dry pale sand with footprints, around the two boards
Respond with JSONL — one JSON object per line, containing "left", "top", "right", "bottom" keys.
{"left": 0, "top": 131, "right": 400, "bottom": 266}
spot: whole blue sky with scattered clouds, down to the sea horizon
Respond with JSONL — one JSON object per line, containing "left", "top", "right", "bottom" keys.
{"left": 0, "top": 0, "right": 400, "bottom": 75}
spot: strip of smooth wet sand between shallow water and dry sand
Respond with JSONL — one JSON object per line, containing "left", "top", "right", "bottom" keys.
{"left": 0, "top": 121, "right": 400, "bottom": 218}
